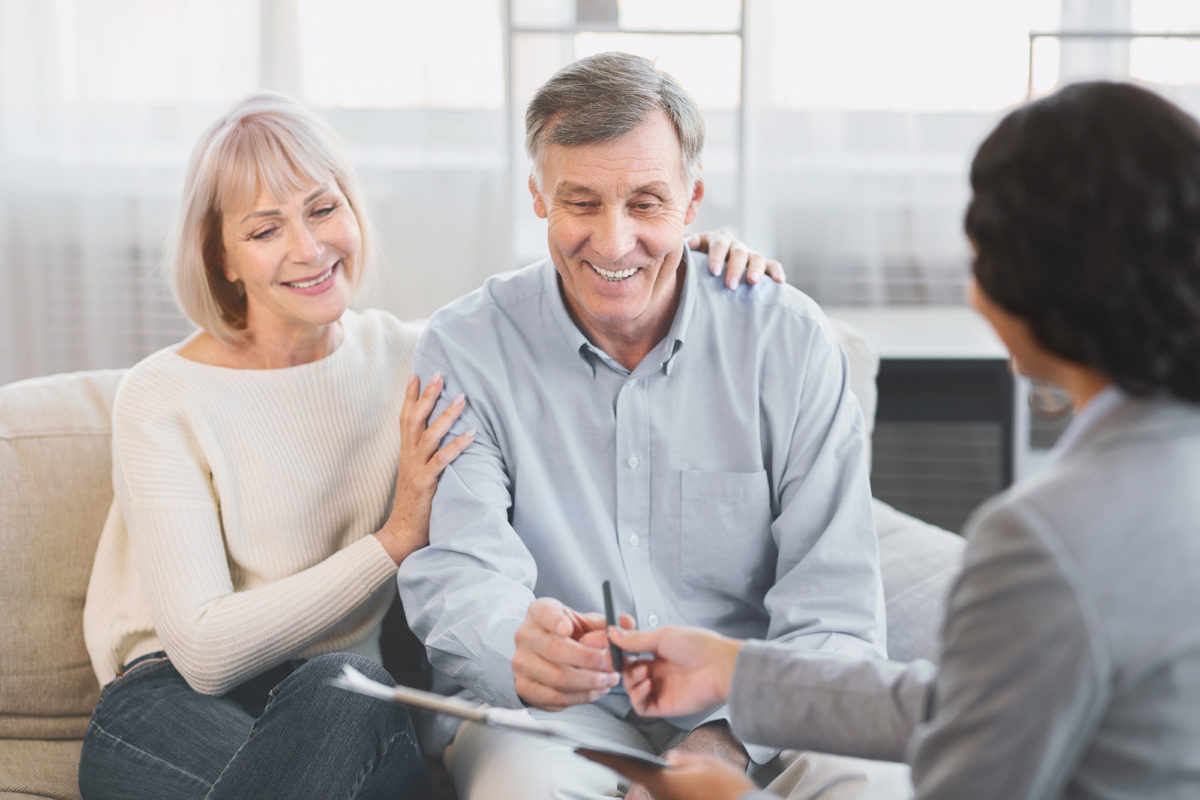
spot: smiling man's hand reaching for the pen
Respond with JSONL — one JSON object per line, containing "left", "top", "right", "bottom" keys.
{"left": 512, "top": 597, "right": 620, "bottom": 711}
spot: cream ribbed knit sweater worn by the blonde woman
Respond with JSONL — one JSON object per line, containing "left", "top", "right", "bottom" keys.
{"left": 84, "top": 312, "right": 420, "bottom": 694}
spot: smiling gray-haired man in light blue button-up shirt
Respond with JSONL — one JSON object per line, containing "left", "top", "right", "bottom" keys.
{"left": 398, "top": 53, "right": 884, "bottom": 800}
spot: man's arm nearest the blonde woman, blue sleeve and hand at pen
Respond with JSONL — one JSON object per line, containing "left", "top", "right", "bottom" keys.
{"left": 398, "top": 329, "right": 619, "bottom": 710}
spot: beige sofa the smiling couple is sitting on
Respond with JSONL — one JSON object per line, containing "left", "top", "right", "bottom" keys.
{"left": 0, "top": 321, "right": 962, "bottom": 799}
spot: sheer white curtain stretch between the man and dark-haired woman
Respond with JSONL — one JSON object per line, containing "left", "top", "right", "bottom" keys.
{"left": 745, "top": 0, "right": 1058, "bottom": 306}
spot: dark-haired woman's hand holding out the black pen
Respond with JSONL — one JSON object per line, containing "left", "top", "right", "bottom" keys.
{"left": 610, "top": 626, "right": 742, "bottom": 717}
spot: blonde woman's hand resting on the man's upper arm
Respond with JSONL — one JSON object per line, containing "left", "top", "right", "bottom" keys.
{"left": 376, "top": 375, "right": 475, "bottom": 564}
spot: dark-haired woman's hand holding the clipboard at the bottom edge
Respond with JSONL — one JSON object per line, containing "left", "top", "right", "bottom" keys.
{"left": 578, "top": 751, "right": 756, "bottom": 800}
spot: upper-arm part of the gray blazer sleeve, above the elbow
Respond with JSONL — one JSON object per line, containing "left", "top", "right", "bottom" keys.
{"left": 908, "top": 503, "right": 1111, "bottom": 800}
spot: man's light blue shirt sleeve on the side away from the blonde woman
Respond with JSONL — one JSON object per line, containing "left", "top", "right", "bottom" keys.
{"left": 763, "top": 318, "right": 887, "bottom": 657}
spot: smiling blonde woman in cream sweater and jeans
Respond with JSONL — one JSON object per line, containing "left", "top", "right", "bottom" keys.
{"left": 79, "top": 95, "right": 782, "bottom": 800}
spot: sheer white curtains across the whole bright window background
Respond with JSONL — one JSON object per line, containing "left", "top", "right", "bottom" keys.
{"left": 0, "top": 0, "right": 1200, "bottom": 383}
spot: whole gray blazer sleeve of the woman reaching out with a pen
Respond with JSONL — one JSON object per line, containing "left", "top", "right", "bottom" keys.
{"left": 730, "top": 504, "right": 1110, "bottom": 800}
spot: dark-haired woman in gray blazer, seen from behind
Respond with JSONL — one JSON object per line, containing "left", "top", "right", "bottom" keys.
{"left": 585, "top": 77, "right": 1200, "bottom": 800}
